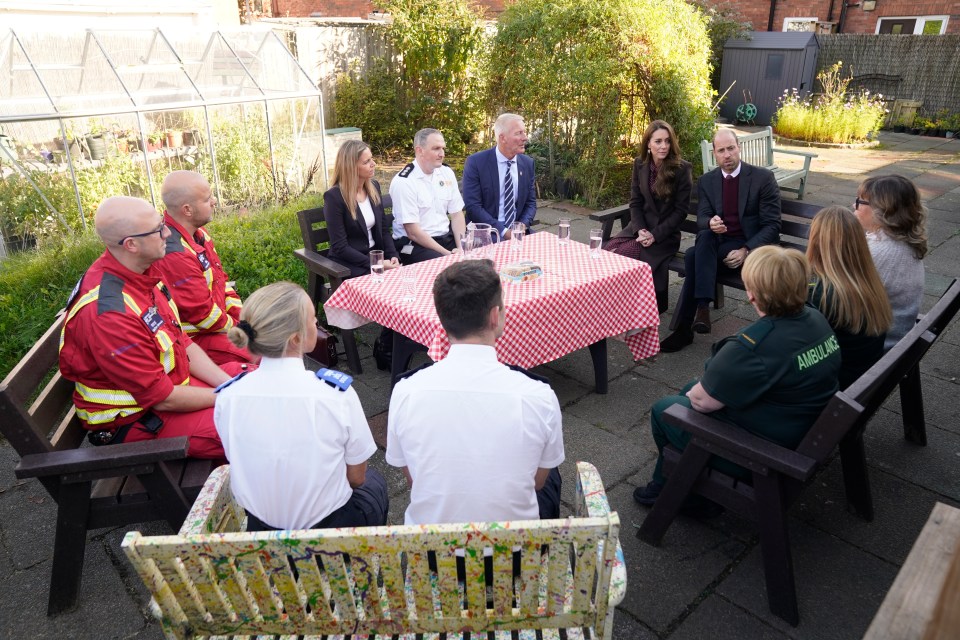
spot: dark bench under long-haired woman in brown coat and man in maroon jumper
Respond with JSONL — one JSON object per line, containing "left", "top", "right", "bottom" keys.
{"left": 590, "top": 200, "right": 823, "bottom": 318}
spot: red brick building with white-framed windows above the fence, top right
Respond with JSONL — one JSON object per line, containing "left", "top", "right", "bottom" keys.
{"left": 720, "top": 0, "right": 960, "bottom": 35}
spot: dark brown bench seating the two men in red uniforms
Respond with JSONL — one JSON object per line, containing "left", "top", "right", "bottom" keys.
{"left": 0, "top": 317, "right": 213, "bottom": 615}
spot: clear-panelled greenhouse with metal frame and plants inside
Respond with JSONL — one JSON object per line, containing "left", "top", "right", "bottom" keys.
{"left": 0, "top": 29, "right": 327, "bottom": 256}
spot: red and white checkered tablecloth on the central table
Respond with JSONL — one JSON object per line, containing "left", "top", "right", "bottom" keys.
{"left": 324, "top": 232, "right": 660, "bottom": 367}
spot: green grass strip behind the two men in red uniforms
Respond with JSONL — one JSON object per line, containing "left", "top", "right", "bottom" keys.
{"left": 0, "top": 198, "right": 318, "bottom": 379}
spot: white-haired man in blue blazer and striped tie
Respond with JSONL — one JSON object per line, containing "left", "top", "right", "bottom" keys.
{"left": 463, "top": 113, "right": 537, "bottom": 239}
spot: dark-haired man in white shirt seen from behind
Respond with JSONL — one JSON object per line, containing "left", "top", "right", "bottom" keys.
{"left": 386, "top": 260, "right": 564, "bottom": 524}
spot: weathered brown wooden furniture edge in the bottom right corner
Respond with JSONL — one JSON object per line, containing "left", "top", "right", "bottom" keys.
{"left": 863, "top": 502, "right": 960, "bottom": 640}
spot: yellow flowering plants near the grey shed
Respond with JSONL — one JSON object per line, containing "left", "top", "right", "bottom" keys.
{"left": 773, "top": 62, "right": 884, "bottom": 143}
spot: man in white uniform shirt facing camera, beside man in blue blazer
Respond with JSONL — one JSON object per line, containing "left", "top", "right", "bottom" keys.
{"left": 390, "top": 129, "right": 465, "bottom": 264}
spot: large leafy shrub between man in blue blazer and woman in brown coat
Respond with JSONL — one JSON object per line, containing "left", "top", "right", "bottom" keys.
{"left": 489, "top": 0, "right": 714, "bottom": 205}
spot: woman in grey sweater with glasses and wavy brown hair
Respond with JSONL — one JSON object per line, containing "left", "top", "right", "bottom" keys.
{"left": 854, "top": 175, "right": 927, "bottom": 349}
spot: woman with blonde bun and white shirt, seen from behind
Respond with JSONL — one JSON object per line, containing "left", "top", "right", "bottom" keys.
{"left": 214, "top": 282, "right": 390, "bottom": 531}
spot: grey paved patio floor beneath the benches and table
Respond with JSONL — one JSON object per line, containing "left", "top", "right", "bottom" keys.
{"left": 0, "top": 133, "right": 960, "bottom": 640}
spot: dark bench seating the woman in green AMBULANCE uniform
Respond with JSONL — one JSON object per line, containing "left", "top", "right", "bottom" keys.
{"left": 637, "top": 280, "right": 960, "bottom": 625}
